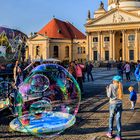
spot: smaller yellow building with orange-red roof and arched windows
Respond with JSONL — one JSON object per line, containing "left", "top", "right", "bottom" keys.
{"left": 26, "top": 18, "right": 87, "bottom": 61}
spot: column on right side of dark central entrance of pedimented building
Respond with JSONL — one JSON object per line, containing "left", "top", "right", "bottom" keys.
{"left": 122, "top": 30, "right": 126, "bottom": 61}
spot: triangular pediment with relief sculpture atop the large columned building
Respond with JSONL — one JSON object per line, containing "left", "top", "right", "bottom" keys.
{"left": 87, "top": 9, "right": 140, "bottom": 26}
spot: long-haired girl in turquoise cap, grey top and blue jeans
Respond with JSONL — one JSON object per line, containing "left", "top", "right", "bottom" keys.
{"left": 106, "top": 75, "right": 123, "bottom": 140}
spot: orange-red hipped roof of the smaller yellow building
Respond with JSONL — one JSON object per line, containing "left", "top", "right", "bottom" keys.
{"left": 38, "top": 18, "right": 86, "bottom": 39}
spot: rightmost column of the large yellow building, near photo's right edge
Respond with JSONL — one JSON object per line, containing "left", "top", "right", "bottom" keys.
{"left": 134, "top": 29, "right": 139, "bottom": 62}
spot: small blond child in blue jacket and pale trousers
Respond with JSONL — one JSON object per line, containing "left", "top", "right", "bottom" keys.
{"left": 128, "top": 86, "right": 137, "bottom": 110}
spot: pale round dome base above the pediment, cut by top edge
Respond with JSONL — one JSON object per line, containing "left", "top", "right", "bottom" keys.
{"left": 108, "top": 0, "right": 140, "bottom": 11}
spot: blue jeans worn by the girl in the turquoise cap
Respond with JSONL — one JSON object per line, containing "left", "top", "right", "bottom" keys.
{"left": 109, "top": 103, "right": 122, "bottom": 137}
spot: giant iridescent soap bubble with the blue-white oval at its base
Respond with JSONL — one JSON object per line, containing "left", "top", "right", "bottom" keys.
{"left": 10, "top": 64, "right": 81, "bottom": 137}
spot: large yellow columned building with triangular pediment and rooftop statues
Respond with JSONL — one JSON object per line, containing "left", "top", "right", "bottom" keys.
{"left": 85, "top": 0, "right": 140, "bottom": 62}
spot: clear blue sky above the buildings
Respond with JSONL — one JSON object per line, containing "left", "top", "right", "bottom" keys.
{"left": 0, "top": 0, "right": 107, "bottom": 35}
